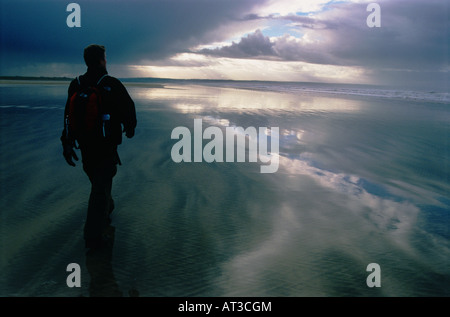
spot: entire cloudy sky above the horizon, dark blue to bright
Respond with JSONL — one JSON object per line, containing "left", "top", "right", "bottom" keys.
{"left": 0, "top": 0, "right": 450, "bottom": 91}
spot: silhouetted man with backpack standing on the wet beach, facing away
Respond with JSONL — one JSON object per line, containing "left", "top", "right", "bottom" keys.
{"left": 61, "top": 45, "right": 137, "bottom": 249}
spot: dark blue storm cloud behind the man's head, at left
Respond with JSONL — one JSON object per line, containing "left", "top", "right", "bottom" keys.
{"left": 1, "top": 0, "right": 261, "bottom": 68}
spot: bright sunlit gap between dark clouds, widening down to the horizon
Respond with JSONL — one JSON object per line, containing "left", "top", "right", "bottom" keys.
{"left": 132, "top": 0, "right": 380, "bottom": 84}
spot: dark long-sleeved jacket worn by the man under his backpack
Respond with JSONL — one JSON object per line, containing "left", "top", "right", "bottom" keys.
{"left": 61, "top": 68, "right": 137, "bottom": 148}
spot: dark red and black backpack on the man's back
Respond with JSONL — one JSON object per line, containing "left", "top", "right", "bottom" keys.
{"left": 65, "top": 75, "right": 110, "bottom": 144}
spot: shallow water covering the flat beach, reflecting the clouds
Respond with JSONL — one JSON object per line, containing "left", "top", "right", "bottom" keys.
{"left": 0, "top": 83, "right": 450, "bottom": 296}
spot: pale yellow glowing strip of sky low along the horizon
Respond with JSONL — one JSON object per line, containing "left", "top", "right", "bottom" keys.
{"left": 133, "top": 53, "right": 370, "bottom": 83}
